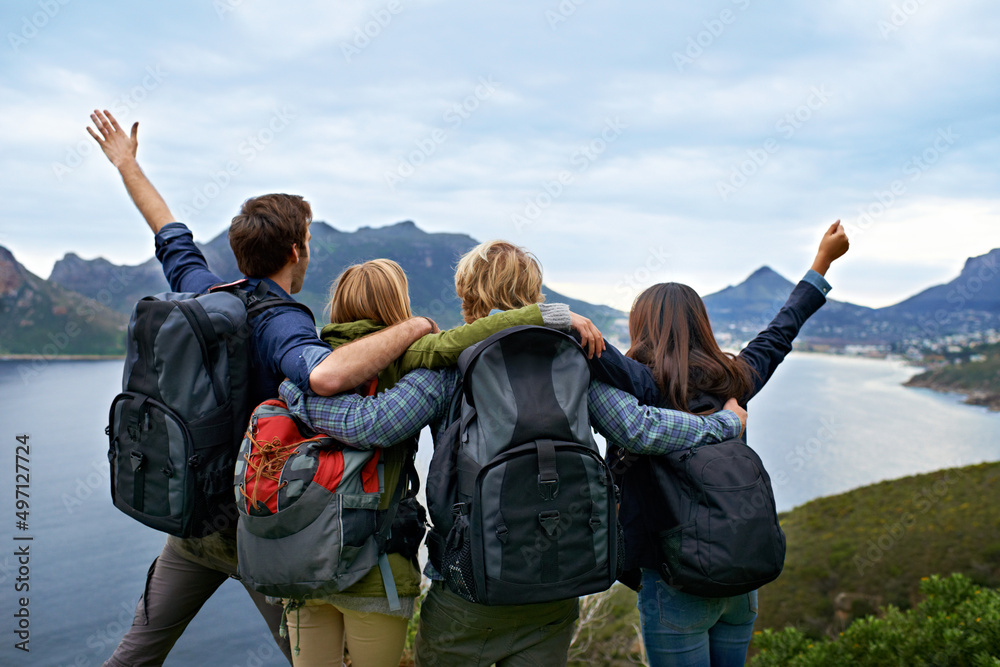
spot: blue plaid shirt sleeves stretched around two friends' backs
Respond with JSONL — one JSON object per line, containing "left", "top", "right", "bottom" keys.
{"left": 279, "top": 367, "right": 741, "bottom": 454}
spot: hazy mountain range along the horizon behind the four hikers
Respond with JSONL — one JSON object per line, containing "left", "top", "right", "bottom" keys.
{"left": 0, "top": 221, "right": 1000, "bottom": 356}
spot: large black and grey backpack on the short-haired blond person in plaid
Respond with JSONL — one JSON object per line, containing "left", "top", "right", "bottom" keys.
{"left": 426, "top": 326, "right": 621, "bottom": 605}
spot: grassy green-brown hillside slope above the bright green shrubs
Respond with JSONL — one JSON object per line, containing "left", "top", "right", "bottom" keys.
{"left": 756, "top": 463, "right": 1000, "bottom": 638}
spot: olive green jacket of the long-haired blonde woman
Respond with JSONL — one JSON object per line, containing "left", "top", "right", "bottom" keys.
{"left": 320, "top": 304, "right": 544, "bottom": 597}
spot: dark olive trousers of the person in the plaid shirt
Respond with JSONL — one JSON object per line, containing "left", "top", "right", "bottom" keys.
{"left": 416, "top": 581, "right": 580, "bottom": 667}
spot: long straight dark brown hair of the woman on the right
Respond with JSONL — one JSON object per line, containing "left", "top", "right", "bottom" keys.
{"left": 626, "top": 283, "right": 754, "bottom": 412}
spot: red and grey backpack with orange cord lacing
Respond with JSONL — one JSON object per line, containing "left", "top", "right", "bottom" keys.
{"left": 235, "top": 400, "right": 419, "bottom": 609}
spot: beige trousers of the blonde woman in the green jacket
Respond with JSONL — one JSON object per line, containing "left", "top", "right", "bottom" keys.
{"left": 285, "top": 604, "right": 409, "bottom": 667}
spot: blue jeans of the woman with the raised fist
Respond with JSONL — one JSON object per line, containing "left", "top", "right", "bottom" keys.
{"left": 638, "top": 568, "right": 757, "bottom": 667}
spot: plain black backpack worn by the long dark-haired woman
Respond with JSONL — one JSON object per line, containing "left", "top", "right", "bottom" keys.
{"left": 609, "top": 396, "right": 785, "bottom": 598}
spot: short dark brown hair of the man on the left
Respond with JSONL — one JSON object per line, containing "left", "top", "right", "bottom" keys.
{"left": 229, "top": 194, "right": 312, "bottom": 278}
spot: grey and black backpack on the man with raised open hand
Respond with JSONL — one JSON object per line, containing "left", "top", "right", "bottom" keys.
{"left": 106, "top": 281, "right": 312, "bottom": 537}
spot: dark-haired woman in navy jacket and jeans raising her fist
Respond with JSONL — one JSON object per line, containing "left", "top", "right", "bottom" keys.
{"left": 592, "top": 220, "right": 849, "bottom": 667}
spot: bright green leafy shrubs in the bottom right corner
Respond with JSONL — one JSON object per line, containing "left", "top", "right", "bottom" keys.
{"left": 750, "top": 574, "right": 1000, "bottom": 667}
